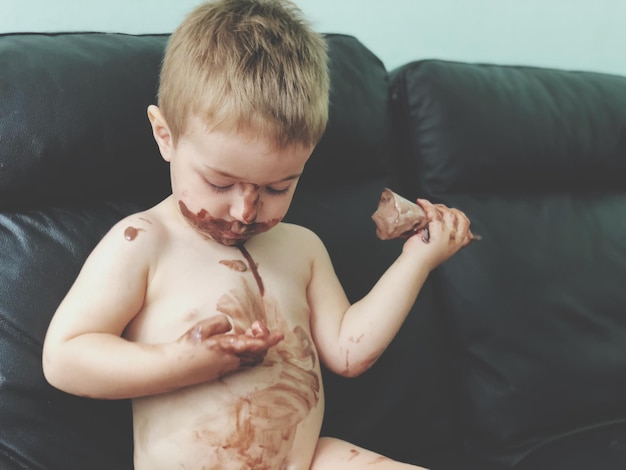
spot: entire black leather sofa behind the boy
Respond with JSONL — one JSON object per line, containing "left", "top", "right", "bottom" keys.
{"left": 0, "top": 33, "right": 626, "bottom": 470}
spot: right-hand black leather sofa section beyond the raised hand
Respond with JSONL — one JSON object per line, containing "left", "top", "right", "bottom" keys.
{"left": 392, "top": 60, "right": 626, "bottom": 468}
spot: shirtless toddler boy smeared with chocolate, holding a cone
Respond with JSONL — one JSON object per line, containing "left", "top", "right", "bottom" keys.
{"left": 43, "top": 0, "right": 469, "bottom": 470}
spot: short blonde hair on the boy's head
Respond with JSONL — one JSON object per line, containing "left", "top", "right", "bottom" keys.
{"left": 159, "top": 0, "right": 329, "bottom": 147}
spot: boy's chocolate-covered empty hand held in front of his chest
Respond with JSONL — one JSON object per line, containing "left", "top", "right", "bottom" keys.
{"left": 178, "top": 315, "right": 284, "bottom": 380}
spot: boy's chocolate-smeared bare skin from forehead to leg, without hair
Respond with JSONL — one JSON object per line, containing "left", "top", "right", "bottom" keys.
{"left": 43, "top": 111, "right": 470, "bottom": 470}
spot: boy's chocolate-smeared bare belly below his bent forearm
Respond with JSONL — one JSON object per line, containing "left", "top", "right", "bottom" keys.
{"left": 133, "top": 348, "right": 324, "bottom": 470}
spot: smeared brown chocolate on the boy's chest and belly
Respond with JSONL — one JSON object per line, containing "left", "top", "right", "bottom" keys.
{"left": 194, "top": 245, "right": 321, "bottom": 470}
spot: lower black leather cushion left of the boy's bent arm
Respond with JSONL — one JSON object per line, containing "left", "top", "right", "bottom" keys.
{"left": 0, "top": 204, "right": 139, "bottom": 470}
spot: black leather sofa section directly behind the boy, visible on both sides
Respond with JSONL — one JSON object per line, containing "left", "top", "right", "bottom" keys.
{"left": 0, "top": 33, "right": 448, "bottom": 470}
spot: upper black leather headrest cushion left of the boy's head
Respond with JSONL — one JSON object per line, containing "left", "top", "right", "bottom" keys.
{"left": 0, "top": 34, "right": 169, "bottom": 207}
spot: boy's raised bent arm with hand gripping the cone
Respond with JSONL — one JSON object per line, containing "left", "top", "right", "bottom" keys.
{"left": 309, "top": 200, "right": 471, "bottom": 376}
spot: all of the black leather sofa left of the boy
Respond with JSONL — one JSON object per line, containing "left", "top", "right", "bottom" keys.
{"left": 0, "top": 34, "right": 168, "bottom": 469}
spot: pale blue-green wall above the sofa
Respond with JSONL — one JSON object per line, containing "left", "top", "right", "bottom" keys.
{"left": 0, "top": 0, "right": 626, "bottom": 75}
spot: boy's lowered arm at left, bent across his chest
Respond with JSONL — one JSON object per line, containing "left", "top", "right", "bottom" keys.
{"left": 43, "top": 220, "right": 281, "bottom": 399}
